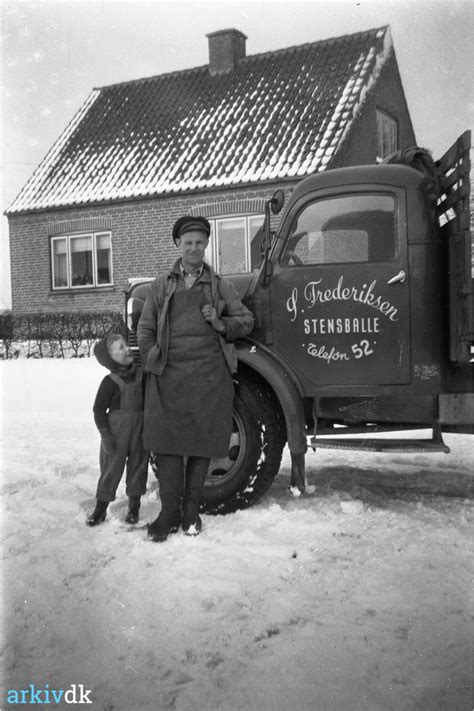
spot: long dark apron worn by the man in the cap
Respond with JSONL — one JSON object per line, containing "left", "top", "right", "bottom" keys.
{"left": 144, "top": 284, "right": 234, "bottom": 458}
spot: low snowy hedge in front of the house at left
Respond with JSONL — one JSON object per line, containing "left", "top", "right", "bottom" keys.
{"left": 0, "top": 311, "right": 125, "bottom": 359}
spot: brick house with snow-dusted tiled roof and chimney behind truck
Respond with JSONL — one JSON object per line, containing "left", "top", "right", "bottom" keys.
{"left": 6, "top": 26, "right": 415, "bottom": 314}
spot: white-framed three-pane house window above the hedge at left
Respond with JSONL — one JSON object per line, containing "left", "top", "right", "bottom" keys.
{"left": 51, "top": 232, "right": 112, "bottom": 289}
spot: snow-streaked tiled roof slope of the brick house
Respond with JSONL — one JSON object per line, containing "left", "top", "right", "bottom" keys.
{"left": 7, "top": 26, "right": 392, "bottom": 214}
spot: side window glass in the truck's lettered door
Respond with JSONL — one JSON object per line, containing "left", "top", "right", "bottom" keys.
{"left": 281, "top": 193, "right": 397, "bottom": 267}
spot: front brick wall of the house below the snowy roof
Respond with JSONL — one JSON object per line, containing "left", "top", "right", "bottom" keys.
{"left": 9, "top": 182, "right": 295, "bottom": 314}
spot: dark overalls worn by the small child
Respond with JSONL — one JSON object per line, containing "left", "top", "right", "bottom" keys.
{"left": 96, "top": 370, "right": 148, "bottom": 501}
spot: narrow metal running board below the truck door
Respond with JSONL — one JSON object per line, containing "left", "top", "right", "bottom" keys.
{"left": 311, "top": 437, "right": 451, "bottom": 454}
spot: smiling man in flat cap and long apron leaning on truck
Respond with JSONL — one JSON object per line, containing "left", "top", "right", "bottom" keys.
{"left": 137, "top": 215, "right": 253, "bottom": 541}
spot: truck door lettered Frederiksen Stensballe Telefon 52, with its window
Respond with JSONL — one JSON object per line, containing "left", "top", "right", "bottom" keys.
{"left": 270, "top": 186, "right": 410, "bottom": 395}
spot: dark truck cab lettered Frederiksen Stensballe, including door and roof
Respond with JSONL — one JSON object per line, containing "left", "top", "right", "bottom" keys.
{"left": 265, "top": 166, "right": 434, "bottom": 390}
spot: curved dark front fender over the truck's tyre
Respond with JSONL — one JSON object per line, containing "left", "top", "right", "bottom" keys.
{"left": 235, "top": 341, "right": 306, "bottom": 454}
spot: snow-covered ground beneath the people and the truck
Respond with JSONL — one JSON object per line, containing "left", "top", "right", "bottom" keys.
{"left": 0, "top": 359, "right": 474, "bottom": 711}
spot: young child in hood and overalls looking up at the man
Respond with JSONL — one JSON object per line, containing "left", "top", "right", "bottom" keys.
{"left": 86, "top": 333, "right": 148, "bottom": 526}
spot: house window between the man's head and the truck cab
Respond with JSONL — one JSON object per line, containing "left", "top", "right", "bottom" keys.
{"left": 206, "top": 215, "right": 263, "bottom": 274}
